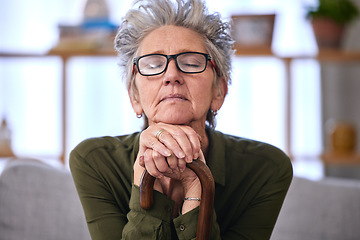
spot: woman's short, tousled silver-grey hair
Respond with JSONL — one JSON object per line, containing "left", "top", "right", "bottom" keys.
{"left": 115, "top": 0, "right": 234, "bottom": 128}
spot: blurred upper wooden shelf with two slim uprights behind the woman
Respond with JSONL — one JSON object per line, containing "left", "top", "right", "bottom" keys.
{"left": 0, "top": 46, "right": 360, "bottom": 163}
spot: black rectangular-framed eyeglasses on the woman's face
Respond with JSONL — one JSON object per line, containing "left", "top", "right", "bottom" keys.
{"left": 133, "top": 52, "right": 218, "bottom": 76}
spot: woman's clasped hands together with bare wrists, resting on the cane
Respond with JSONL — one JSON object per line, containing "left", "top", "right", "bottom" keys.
{"left": 134, "top": 123, "right": 205, "bottom": 213}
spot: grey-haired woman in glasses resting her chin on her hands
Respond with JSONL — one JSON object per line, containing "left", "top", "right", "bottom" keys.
{"left": 70, "top": 0, "right": 292, "bottom": 240}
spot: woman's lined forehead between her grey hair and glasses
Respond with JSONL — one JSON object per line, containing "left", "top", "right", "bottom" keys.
{"left": 139, "top": 25, "right": 207, "bottom": 55}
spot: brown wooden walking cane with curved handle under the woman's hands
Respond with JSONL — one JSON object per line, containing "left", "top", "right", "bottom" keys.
{"left": 140, "top": 159, "right": 215, "bottom": 240}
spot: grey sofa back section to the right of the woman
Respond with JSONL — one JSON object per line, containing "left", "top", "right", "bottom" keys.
{"left": 271, "top": 177, "right": 360, "bottom": 240}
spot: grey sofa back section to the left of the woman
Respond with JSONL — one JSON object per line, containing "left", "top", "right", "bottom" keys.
{"left": 0, "top": 160, "right": 90, "bottom": 240}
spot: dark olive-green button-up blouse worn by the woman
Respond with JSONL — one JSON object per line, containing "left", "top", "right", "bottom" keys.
{"left": 70, "top": 130, "right": 292, "bottom": 240}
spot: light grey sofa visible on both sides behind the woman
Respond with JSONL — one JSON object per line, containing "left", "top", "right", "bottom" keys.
{"left": 0, "top": 159, "right": 360, "bottom": 240}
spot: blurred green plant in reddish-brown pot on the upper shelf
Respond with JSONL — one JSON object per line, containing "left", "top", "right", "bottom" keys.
{"left": 307, "top": 0, "right": 359, "bottom": 48}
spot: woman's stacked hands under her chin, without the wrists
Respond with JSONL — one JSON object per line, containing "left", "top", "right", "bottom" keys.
{"left": 138, "top": 124, "right": 201, "bottom": 178}
